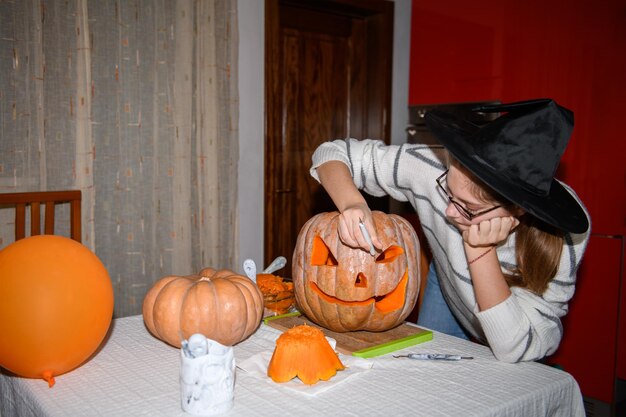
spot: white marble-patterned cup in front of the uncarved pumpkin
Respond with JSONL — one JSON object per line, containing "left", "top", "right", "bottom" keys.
{"left": 180, "top": 335, "right": 235, "bottom": 416}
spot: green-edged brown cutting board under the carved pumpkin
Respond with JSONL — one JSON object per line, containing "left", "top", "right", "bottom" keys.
{"left": 264, "top": 313, "right": 433, "bottom": 358}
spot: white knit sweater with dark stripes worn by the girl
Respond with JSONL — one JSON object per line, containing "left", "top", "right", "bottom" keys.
{"left": 311, "top": 139, "right": 590, "bottom": 362}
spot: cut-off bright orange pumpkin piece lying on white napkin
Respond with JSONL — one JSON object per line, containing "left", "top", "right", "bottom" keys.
{"left": 267, "top": 324, "right": 345, "bottom": 385}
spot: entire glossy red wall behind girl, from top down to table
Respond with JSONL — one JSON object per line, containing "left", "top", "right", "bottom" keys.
{"left": 409, "top": 0, "right": 626, "bottom": 403}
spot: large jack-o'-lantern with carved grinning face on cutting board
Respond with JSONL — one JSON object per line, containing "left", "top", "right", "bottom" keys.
{"left": 293, "top": 211, "right": 421, "bottom": 332}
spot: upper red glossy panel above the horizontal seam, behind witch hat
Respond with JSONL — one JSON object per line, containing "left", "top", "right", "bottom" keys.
{"left": 409, "top": 0, "right": 626, "bottom": 235}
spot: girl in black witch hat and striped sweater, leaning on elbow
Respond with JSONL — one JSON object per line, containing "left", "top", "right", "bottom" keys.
{"left": 311, "top": 99, "right": 590, "bottom": 362}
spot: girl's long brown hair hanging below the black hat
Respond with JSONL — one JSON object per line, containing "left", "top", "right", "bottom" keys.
{"left": 451, "top": 160, "right": 564, "bottom": 295}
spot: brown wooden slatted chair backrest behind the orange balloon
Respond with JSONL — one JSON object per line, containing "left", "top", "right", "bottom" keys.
{"left": 0, "top": 190, "right": 82, "bottom": 242}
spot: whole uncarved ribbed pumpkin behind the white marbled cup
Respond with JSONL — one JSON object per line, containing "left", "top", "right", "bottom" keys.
{"left": 143, "top": 268, "right": 263, "bottom": 347}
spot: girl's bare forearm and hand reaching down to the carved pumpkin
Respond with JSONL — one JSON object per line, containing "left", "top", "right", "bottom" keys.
{"left": 317, "top": 161, "right": 382, "bottom": 251}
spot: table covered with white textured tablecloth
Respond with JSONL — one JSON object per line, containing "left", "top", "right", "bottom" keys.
{"left": 0, "top": 316, "right": 585, "bottom": 417}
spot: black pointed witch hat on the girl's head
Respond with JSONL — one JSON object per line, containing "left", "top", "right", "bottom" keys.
{"left": 425, "top": 99, "right": 589, "bottom": 233}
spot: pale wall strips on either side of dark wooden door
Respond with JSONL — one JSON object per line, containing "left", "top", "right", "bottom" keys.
{"left": 237, "top": 0, "right": 411, "bottom": 272}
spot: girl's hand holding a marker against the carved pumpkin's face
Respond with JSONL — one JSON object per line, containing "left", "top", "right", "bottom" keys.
{"left": 339, "top": 203, "right": 382, "bottom": 252}
